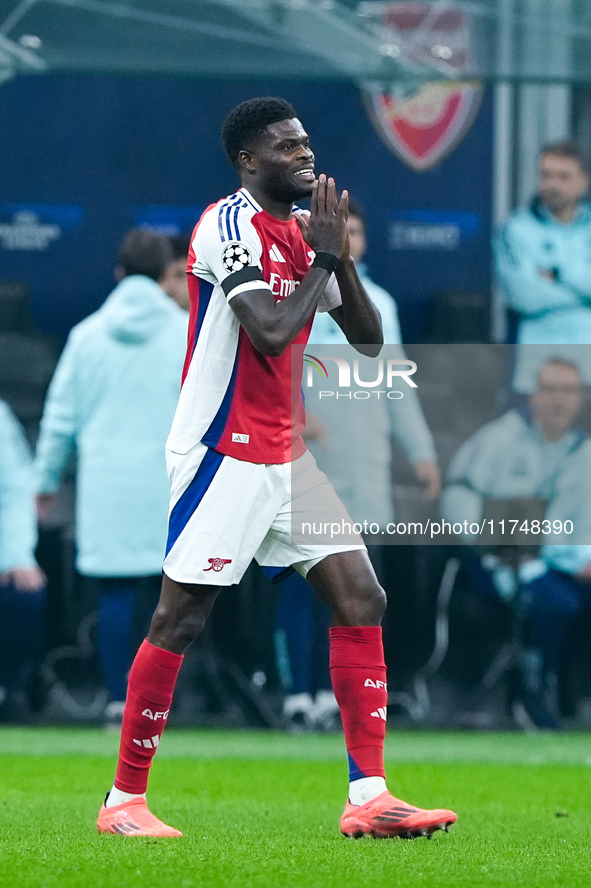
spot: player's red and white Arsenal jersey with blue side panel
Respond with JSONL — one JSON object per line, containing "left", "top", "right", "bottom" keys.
{"left": 168, "top": 188, "right": 340, "bottom": 463}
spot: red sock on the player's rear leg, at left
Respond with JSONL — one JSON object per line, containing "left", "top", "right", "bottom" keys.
{"left": 115, "top": 639, "right": 183, "bottom": 795}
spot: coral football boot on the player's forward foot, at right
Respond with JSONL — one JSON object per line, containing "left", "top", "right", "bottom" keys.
{"left": 341, "top": 791, "right": 458, "bottom": 839}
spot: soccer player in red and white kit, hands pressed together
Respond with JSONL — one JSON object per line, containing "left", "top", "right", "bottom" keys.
{"left": 98, "top": 98, "right": 456, "bottom": 837}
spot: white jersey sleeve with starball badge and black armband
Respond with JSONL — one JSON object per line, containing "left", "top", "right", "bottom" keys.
{"left": 191, "top": 204, "right": 269, "bottom": 301}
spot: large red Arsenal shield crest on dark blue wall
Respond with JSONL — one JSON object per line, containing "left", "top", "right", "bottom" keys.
{"left": 363, "top": 2, "right": 482, "bottom": 171}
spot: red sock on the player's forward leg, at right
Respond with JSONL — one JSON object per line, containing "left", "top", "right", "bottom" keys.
{"left": 330, "top": 626, "right": 388, "bottom": 780}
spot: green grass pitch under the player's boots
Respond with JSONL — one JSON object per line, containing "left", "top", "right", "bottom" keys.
{"left": 0, "top": 727, "right": 591, "bottom": 888}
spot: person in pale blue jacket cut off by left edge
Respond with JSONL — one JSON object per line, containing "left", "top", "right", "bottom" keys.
{"left": 0, "top": 401, "right": 46, "bottom": 720}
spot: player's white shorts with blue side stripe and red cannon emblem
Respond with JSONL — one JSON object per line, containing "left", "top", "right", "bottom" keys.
{"left": 164, "top": 443, "right": 365, "bottom": 586}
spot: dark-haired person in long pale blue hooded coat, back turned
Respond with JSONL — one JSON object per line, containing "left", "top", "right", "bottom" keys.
{"left": 36, "top": 229, "right": 188, "bottom": 723}
